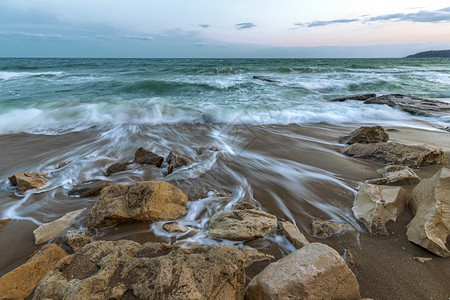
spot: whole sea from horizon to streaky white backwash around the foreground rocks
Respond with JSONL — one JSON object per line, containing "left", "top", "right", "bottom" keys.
{"left": 0, "top": 58, "right": 450, "bottom": 253}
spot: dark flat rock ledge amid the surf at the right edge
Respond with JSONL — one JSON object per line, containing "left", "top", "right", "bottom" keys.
{"left": 364, "top": 94, "right": 450, "bottom": 116}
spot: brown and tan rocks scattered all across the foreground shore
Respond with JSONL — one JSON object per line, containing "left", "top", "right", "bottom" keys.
{"left": 0, "top": 122, "right": 450, "bottom": 299}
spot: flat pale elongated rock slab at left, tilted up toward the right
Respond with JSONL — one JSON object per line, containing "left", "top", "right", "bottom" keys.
{"left": 33, "top": 208, "right": 86, "bottom": 245}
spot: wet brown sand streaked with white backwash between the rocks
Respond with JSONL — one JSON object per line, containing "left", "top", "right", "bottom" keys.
{"left": 0, "top": 124, "right": 450, "bottom": 299}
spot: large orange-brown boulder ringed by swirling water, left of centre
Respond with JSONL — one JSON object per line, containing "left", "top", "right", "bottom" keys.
{"left": 88, "top": 181, "right": 188, "bottom": 227}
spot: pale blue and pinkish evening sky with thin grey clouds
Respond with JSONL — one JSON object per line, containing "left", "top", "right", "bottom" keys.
{"left": 0, "top": 0, "right": 450, "bottom": 58}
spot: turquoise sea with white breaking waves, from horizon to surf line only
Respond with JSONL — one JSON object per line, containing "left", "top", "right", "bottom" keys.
{"left": 0, "top": 59, "right": 450, "bottom": 134}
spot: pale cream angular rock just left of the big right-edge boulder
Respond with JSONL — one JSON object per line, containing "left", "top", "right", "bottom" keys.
{"left": 352, "top": 184, "right": 407, "bottom": 234}
